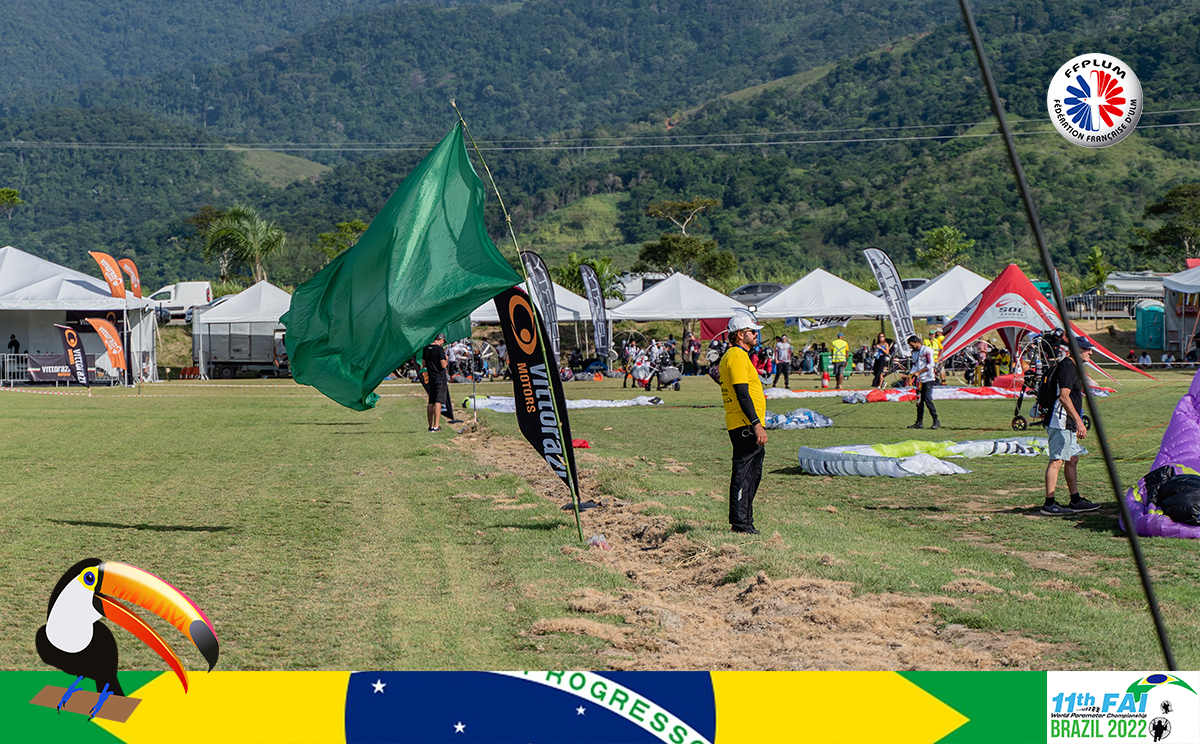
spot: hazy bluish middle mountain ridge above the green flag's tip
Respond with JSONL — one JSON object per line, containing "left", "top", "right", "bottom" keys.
{"left": 0, "top": 0, "right": 1012, "bottom": 151}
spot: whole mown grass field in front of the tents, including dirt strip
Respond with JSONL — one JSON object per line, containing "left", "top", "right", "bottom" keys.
{"left": 0, "top": 371, "right": 1200, "bottom": 670}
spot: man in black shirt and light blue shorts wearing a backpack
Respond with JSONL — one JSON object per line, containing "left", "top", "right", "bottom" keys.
{"left": 1038, "top": 336, "right": 1100, "bottom": 517}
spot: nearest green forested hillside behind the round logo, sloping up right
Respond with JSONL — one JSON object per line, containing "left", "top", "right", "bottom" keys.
{"left": 260, "top": 0, "right": 1200, "bottom": 277}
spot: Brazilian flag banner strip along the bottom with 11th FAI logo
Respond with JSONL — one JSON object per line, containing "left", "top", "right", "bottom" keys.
{"left": 0, "top": 670, "right": 1200, "bottom": 744}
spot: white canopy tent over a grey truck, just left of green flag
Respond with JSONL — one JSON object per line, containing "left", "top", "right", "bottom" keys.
{"left": 192, "top": 280, "right": 292, "bottom": 374}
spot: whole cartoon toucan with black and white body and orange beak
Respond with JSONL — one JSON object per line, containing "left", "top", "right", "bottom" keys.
{"left": 36, "top": 558, "right": 220, "bottom": 718}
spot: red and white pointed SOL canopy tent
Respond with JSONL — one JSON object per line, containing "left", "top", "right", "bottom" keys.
{"left": 942, "top": 264, "right": 1154, "bottom": 379}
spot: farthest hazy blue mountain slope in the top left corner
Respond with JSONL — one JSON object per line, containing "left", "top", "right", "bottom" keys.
{"left": 0, "top": 0, "right": 469, "bottom": 96}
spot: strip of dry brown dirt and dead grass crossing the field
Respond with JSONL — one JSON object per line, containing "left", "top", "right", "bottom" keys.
{"left": 455, "top": 430, "right": 1057, "bottom": 670}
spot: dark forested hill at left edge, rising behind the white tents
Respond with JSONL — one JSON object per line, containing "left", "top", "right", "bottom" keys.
{"left": 0, "top": 109, "right": 265, "bottom": 284}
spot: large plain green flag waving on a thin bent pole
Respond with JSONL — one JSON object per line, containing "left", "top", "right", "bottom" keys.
{"left": 280, "top": 122, "right": 521, "bottom": 410}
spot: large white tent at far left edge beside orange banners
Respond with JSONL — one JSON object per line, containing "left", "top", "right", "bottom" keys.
{"left": 0, "top": 246, "right": 157, "bottom": 379}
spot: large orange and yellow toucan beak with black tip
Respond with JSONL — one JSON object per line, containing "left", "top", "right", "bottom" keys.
{"left": 96, "top": 562, "right": 220, "bottom": 692}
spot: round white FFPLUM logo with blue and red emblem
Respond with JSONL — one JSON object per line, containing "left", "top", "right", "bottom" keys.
{"left": 1046, "top": 54, "right": 1144, "bottom": 148}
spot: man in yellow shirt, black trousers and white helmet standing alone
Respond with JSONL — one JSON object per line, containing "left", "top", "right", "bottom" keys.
{"left": 720, "top": 313, "right": 767, "bottom": 535}
